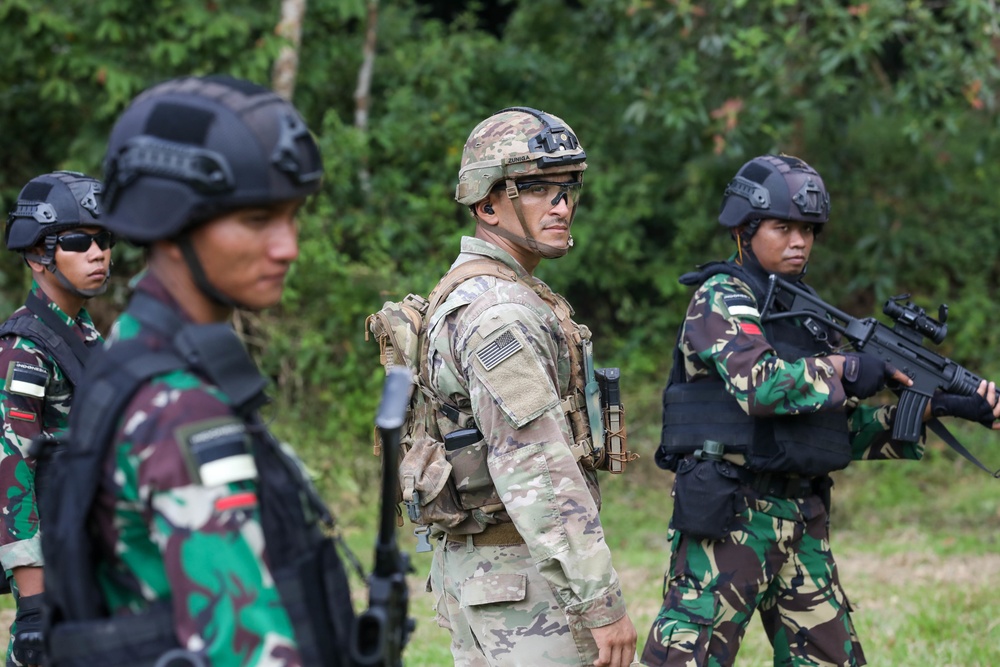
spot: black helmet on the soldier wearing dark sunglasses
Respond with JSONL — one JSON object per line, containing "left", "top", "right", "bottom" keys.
{"left": 4, "top": 171, "right": 105, "bottom": 251}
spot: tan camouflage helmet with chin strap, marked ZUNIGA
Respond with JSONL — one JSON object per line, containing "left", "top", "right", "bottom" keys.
{"left": 455, "top": 107, "right": 587, "bottom": 257}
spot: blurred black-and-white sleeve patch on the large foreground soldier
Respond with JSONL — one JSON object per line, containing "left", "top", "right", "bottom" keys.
{"left": 175, "top": 417, "right": 257, "bottom": 486}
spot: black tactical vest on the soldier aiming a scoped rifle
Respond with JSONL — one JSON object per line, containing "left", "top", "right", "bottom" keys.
{"left": 656, "top": 262, "right": 851, "bottom": 476}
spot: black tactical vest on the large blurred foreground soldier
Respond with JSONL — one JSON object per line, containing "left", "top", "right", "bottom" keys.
{"left": 42, "top": 292, "right": 354, "bottom": 667}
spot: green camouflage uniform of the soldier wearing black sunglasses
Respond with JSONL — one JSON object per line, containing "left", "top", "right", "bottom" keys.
{"left": 0, "top": 283, "right": 101, "bottom": 665}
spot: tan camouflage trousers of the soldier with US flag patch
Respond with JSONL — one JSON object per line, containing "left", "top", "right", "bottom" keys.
{"left": 429, "top": 539, "right": 598, "bottom": 667}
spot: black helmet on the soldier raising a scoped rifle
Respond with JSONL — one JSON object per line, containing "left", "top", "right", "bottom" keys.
{"left": 719, "top": 155, "right": 830, "bottom": 228}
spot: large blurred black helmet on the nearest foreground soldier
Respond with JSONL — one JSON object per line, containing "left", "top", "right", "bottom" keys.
{"left": 103, "top": 76, "right": 323, "bottom": 244}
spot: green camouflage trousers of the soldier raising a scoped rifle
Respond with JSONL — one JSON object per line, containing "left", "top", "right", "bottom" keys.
{"left": 642, "top": 491, "right": 866, "bottom": 667}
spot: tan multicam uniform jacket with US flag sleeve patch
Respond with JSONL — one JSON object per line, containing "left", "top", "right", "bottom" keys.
{"left": 428, "top": 237, "right": 625, "bottom": 628}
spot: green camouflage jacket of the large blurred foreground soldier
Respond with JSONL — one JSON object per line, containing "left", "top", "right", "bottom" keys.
{"left": 92, "top": 275, "right": 301, "bottom": 667}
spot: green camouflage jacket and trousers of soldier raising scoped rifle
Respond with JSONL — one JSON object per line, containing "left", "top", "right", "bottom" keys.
{"left": 642, "top": 274, "right": 923, "bottom": 667}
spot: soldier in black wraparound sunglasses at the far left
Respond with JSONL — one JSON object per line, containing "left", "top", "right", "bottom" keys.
{"left": 0, "top": 171, "right": 114, "bottom": 665}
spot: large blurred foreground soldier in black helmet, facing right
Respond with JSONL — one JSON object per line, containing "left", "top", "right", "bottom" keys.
{"left": 43, "top": 77, "right": 354, "bottom": 667}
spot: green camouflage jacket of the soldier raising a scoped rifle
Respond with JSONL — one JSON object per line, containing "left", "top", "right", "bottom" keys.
{"left": 680, "top": 264, "right": 923, "bottom": 460}
